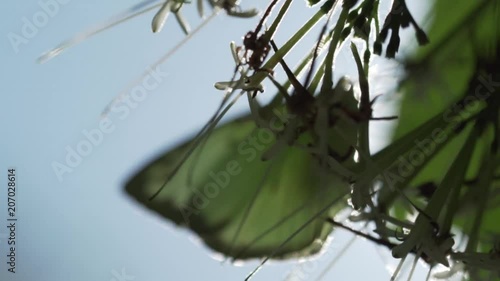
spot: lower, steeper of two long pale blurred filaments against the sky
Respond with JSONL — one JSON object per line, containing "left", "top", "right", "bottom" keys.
{"left": 101, "top": 7, "right": 220, "bottom": 118}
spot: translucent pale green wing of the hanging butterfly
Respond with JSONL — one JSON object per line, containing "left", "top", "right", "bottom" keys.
{"left": 126, "top": 112, "right": 349, "bottom": 259}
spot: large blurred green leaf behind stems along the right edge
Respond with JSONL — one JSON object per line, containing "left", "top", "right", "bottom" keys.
{"left": 379, "top": 0, "right": 500, "bottom": 280}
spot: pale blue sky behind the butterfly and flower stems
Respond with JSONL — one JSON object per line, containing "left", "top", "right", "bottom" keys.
{"left": 0, "top": 0, "right": 434, "bottom": 281}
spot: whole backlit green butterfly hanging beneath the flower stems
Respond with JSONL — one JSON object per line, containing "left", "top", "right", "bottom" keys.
{"left": 121, "top": 1, "right": 374, "bottom": 259}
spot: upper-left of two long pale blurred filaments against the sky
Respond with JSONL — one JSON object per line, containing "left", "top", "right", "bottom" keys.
{"left": 37, "top": 0, "right": 162, "bottom": 64}
